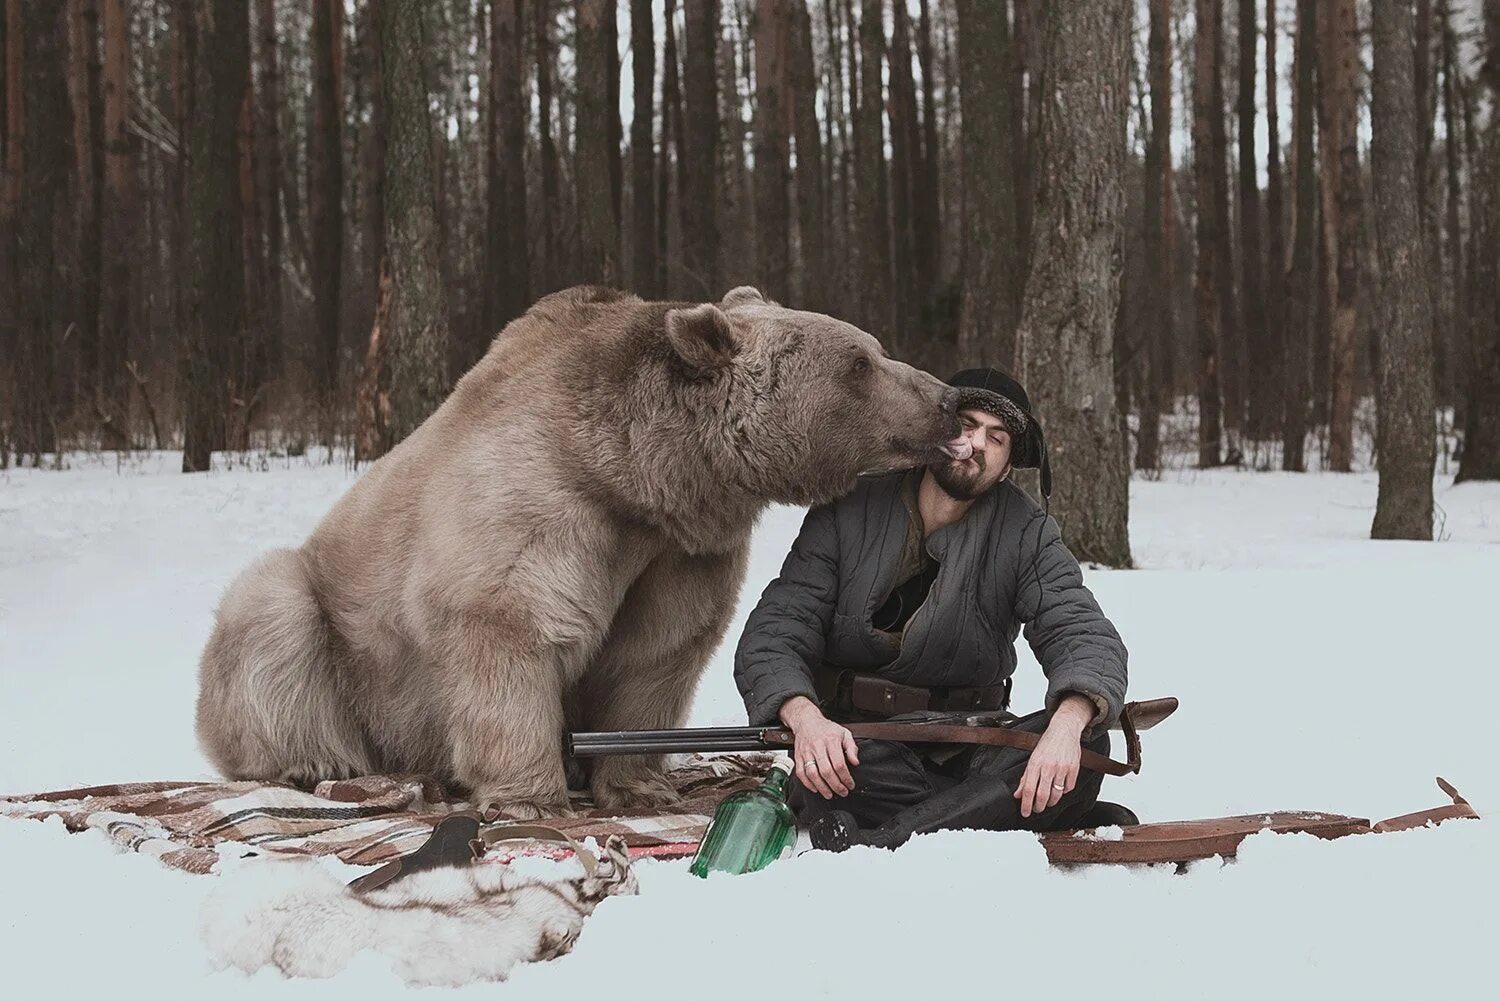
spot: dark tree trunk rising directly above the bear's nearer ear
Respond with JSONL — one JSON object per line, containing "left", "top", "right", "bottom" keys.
{"left": 680, "top": 0, "right": 723, "bottom": 299}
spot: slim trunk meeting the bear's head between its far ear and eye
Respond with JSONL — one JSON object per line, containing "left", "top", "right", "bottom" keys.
{"left": 791, "top": 0, "right": 834, "bottom": 311}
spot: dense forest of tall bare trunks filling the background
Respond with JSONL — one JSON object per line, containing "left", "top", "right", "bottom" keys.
{"left": 0, "top": 0, "right": 1500, "bottom": 566}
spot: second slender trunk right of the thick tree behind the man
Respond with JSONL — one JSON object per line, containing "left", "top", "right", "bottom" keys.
{"left": 1193, "top": 0, "right": 1224, "bottom": 467}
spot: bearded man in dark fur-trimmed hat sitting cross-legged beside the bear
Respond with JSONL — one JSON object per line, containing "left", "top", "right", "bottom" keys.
{"left": 735, "top": 369, "right": 1136, "bottom": 851}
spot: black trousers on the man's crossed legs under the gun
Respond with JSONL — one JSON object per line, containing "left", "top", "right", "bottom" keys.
{"left": 788, "top": 710, "right": 1110, "bottom": 843}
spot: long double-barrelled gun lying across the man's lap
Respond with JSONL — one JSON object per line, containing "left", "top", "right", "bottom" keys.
{"left": 566, "top": 696, "right": 1178, "bottom": 776}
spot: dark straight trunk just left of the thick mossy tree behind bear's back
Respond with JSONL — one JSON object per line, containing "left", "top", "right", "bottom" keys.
{"left": 308, "top": 0, "right": 344, "bottom": 423}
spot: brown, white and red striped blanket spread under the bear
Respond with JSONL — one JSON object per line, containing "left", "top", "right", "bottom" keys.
{"left": 0, "top": 755, "right": 773, "bottom": 873}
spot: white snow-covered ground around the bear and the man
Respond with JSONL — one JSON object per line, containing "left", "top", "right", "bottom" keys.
{"left": 0, "top": 455, "right": 1500, "bottom": 998}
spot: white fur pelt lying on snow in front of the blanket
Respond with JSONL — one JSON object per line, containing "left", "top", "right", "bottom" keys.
{"left": 203, "top": 837, "right": 638, "bottom": 986}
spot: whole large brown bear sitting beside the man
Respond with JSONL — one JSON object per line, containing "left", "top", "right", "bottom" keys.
{"left": 198, "top": 287, "right": 959, "bottom": 818}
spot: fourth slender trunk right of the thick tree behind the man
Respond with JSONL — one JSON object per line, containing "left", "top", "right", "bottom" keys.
{"left": 1260, "top": 0, "right": 1287, "bottom": 450}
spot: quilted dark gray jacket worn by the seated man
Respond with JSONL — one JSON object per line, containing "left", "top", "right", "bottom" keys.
{"left": 735, "top": 470, "right": 1125, "bottom": 740}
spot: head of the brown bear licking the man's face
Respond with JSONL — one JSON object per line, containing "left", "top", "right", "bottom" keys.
{"left": 666, "top": 287, "right": 959, "bottom": 504}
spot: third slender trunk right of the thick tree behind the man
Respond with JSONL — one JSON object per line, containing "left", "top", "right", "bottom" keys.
{"left": 1239, "top": 0, "right": 1275, "bottom": 440}
